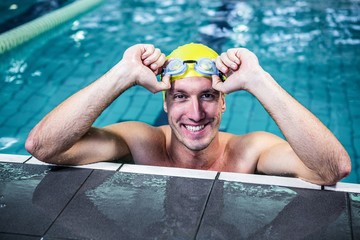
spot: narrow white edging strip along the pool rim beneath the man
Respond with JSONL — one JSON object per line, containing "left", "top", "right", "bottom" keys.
{"left": 0, "top": 154, "right": 360, "bottom": 193}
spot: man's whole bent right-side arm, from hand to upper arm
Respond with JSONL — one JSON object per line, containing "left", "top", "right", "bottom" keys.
{"left": 213, "top": 48, "right": 351, "bottom": 185}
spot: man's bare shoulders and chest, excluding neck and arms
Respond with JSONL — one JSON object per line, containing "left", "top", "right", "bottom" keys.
{"left": 108, "top": 122, "right": 283, "bottom": 173}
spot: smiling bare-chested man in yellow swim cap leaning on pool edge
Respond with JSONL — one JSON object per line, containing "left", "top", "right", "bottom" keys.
{"left": 26, "top": 44, "right": 351, "bottom": 185}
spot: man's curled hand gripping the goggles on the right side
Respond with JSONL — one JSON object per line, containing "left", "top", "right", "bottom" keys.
{"left": 212, "top": 48, "right": 265, "bottom": 93}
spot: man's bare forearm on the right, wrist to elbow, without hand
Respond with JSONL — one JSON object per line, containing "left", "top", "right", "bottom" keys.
{"left": 247, "top": 72, "right": 350, "bottom": 183}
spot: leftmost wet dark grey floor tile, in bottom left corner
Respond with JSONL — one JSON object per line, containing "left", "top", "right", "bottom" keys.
{"left": 0, "top": 163, "right": 91, "bottom": 234}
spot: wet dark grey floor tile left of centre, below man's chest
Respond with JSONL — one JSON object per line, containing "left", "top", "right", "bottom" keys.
{"left": 36, "top": 171, "right": 212, "bottom": 239}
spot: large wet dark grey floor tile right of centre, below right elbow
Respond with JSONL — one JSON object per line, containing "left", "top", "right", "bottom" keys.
{"left": 199, "top": 181, "right": 351, "bottom": 239}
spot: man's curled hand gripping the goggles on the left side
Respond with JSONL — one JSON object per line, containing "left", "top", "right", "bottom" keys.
{"left": 121, "top": 44, "right": 170, "bottom": 93}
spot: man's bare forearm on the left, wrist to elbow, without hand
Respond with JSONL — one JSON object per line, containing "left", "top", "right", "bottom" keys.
{"left": 26, "top": 62, "right": 131, "bottom": 160}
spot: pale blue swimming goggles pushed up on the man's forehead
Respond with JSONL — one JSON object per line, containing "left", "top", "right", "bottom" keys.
{"left": 163, "top": 58, "right": 223, "bottom": 79}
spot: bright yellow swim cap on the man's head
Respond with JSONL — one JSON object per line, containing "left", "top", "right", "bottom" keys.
{"left": 166, "top": 43, "right": 219, "bottom": 81}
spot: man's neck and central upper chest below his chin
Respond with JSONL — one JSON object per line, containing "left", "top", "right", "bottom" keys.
{"left": 167, "top": 132, "right": 224, "bottom": 170}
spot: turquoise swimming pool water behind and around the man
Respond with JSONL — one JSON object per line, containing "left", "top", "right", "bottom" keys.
{"left": 0, "top": 0, "right": 360, "bottom": 183}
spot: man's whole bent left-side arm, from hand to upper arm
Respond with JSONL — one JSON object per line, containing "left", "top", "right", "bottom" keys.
{"left": 25, "top": 44, "right": 170, "bottom": 164}
